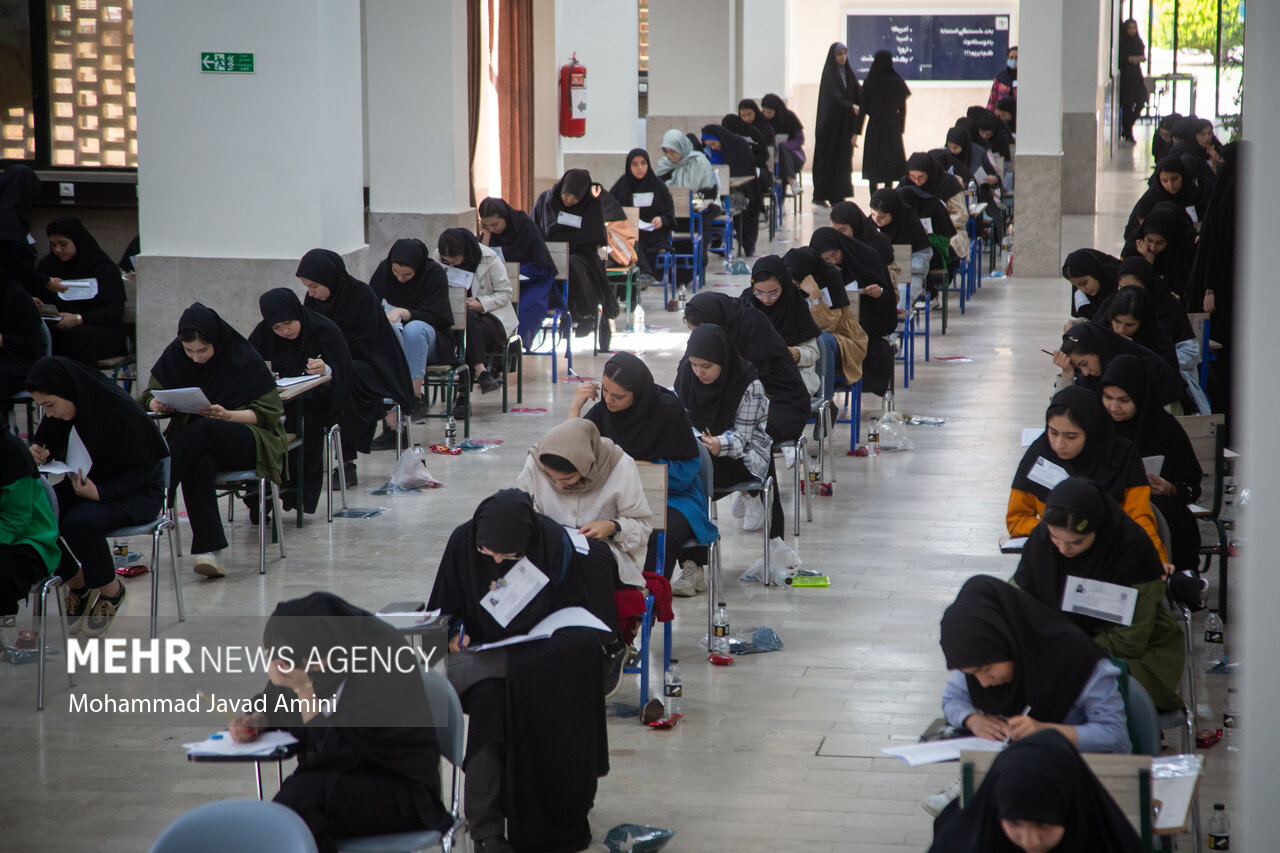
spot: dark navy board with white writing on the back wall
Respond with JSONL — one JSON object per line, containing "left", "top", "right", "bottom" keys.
{"left": 845, "top": 14, "right": 1010, "bottom": 81}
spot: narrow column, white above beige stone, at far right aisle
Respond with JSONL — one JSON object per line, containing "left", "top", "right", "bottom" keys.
{"left": 1014, "top": 0, "right": 1065, "bottom": 278}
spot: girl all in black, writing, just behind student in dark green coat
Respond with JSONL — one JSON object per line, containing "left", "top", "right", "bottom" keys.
{"left": 244, "top": 287, "right": 355, "bottom": 519}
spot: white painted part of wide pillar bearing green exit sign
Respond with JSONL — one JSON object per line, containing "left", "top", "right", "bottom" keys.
{"left": 134, "top": 0, "right": 364, "bottom": 257}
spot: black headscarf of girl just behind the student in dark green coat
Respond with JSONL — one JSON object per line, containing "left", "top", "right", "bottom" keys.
{"left": 248, "top": 287, "right": 352, "bottom": 424}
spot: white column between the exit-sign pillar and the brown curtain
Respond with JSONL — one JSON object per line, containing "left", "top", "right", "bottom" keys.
{"left": 365, "top": 0, "right": 475, "bottom": 266}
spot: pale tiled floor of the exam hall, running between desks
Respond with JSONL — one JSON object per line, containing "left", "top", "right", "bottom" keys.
{"left": 0, "top": 149, "right": 1234, "bottom": 853}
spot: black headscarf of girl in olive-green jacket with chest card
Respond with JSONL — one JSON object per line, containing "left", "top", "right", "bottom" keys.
{"left": 1014, "top": 476, "right": 1165, "bottom": 634}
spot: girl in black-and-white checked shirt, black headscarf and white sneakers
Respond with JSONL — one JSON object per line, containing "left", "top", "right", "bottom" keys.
{"left": 675, "top": 323, "right": 786, "bottom": 539}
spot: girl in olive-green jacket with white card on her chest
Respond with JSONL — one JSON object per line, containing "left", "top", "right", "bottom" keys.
{"left": 1012, "top": 476, "right": 1187, "bottom": 711}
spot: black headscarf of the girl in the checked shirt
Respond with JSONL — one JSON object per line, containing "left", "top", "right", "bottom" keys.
{"left": 676, "top": 323, "right": 759, "bottom": 435}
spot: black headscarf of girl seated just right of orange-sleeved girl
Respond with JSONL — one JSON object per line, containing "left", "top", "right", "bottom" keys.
{"left": 1098, "top": 355, "right": 1204, "bottom": 502}
